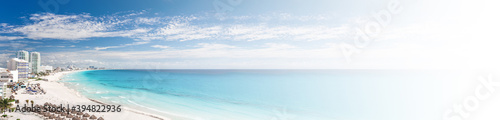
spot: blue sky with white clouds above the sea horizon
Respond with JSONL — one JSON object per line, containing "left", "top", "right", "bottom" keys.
{"left": 0, "top": 0, "right": 500, "bottom": 69}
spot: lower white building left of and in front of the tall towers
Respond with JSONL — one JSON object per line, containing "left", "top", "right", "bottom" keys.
{"left": 7, "top": 58, "right": 29, "bottom": 82}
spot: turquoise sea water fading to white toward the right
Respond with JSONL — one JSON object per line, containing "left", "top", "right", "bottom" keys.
{"left": 62, "top": 70, "right": 484, "bottom": 120}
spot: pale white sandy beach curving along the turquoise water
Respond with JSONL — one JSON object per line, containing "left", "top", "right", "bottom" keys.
{"left": 7, "top": 71, "right": 170, "bottom": 120}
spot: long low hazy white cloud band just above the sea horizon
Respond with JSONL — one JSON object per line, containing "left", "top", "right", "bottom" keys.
{"left": 44, "top": 43, "right": 340, "bottom": 68}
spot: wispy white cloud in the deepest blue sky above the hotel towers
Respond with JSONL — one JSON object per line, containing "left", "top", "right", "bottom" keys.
{"left": 12, "top": 13, "right": 149, "bottom": 40}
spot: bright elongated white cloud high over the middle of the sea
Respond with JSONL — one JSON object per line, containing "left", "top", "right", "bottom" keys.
{"left": 139, "top": 23, "right": 350, "bottom": 41}
